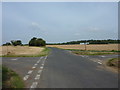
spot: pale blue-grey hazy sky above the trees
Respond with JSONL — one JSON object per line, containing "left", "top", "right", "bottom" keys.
{"left": 2, "top": 2, "right": 118, "bottom": 43}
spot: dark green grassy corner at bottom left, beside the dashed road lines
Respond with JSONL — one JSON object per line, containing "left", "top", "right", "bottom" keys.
{"left": 2, "top": 66, "right": 25, "bottom": 88}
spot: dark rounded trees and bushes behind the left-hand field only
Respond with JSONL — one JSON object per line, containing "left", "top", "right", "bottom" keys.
{"left": 3, "top": 37, "right": 46, "bottom": 46}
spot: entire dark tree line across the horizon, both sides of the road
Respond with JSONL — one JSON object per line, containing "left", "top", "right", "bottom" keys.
{"left": 3, "top": 37, "right": 120, "bottom": 46}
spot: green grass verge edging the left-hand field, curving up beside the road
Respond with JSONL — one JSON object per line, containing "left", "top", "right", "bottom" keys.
{"left": 1, "top": 47, "right": 50, "bottom": 57}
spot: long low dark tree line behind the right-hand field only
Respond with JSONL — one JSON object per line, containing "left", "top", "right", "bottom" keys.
{"left": 47, "top": 39, "right": 120, "bottom": 45}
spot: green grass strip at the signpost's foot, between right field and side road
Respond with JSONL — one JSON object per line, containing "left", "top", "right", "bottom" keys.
{"left": 65, "top": 49, "right": 120, "bottom": 55}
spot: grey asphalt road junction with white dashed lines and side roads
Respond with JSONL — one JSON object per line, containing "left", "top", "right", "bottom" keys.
{"left": 3, "top": 48, "right": 118, "bottom": 88}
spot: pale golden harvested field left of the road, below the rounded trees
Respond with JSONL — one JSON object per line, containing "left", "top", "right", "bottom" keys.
{"left": 0, "top": 46, "right": 45, "bottom": 56}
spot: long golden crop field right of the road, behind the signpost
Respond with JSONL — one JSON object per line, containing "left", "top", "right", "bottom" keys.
{"left": 47, "top": 44, "right": 120, "bottom": 51}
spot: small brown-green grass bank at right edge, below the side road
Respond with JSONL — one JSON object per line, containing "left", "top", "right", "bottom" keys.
{"left": 107, "top": 58, "right": 120, "bottom": 68}
